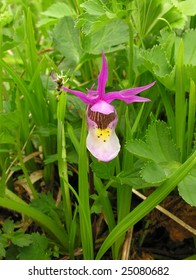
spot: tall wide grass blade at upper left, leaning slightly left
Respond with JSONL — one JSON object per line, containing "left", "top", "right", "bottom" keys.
{"left": 25, "top": 8, "right": 53, "bottom": 183}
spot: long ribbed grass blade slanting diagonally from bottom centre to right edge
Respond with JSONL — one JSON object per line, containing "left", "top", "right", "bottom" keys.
{"left": 96, "top": 151, "right": 196, "bottom": 260}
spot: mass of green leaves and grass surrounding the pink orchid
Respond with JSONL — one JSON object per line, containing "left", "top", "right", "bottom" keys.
{"left": 0, "top": 0, "right": 196, "bottom": 259}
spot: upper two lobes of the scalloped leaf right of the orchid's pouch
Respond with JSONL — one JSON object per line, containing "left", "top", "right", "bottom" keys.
{"left": 126, "top": 121, "right": 180, "bottom": 163}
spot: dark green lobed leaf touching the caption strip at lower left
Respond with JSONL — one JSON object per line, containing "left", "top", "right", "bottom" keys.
{"left": 18, "top": 233, "right": 50, "bottom": 260}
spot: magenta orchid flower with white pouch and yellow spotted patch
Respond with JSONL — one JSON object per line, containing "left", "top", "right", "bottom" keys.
{"left": 55, "top": 53, "right": 155, "bottom": 162}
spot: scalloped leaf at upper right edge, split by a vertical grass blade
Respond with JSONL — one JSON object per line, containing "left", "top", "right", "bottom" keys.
{"left": 140, "top": 30, "right": 196, "bottom": 91}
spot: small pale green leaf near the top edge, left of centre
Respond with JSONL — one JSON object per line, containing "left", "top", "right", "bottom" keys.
{"left": 41, "top": 2, "right": 76, "bottom": 18}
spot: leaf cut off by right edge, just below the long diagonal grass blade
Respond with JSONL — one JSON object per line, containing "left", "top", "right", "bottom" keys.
{"left": 178, "top": 169, "right": 196, "bottom": 206}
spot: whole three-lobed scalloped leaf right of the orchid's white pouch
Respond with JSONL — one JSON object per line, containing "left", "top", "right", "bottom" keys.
{"left": 126, "top": 121, "right": 180, "bottom": 186}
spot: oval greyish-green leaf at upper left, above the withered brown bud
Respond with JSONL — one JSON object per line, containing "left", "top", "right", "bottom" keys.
{"left": 54, "top": 17, "right": 82, "bottom": 67}
